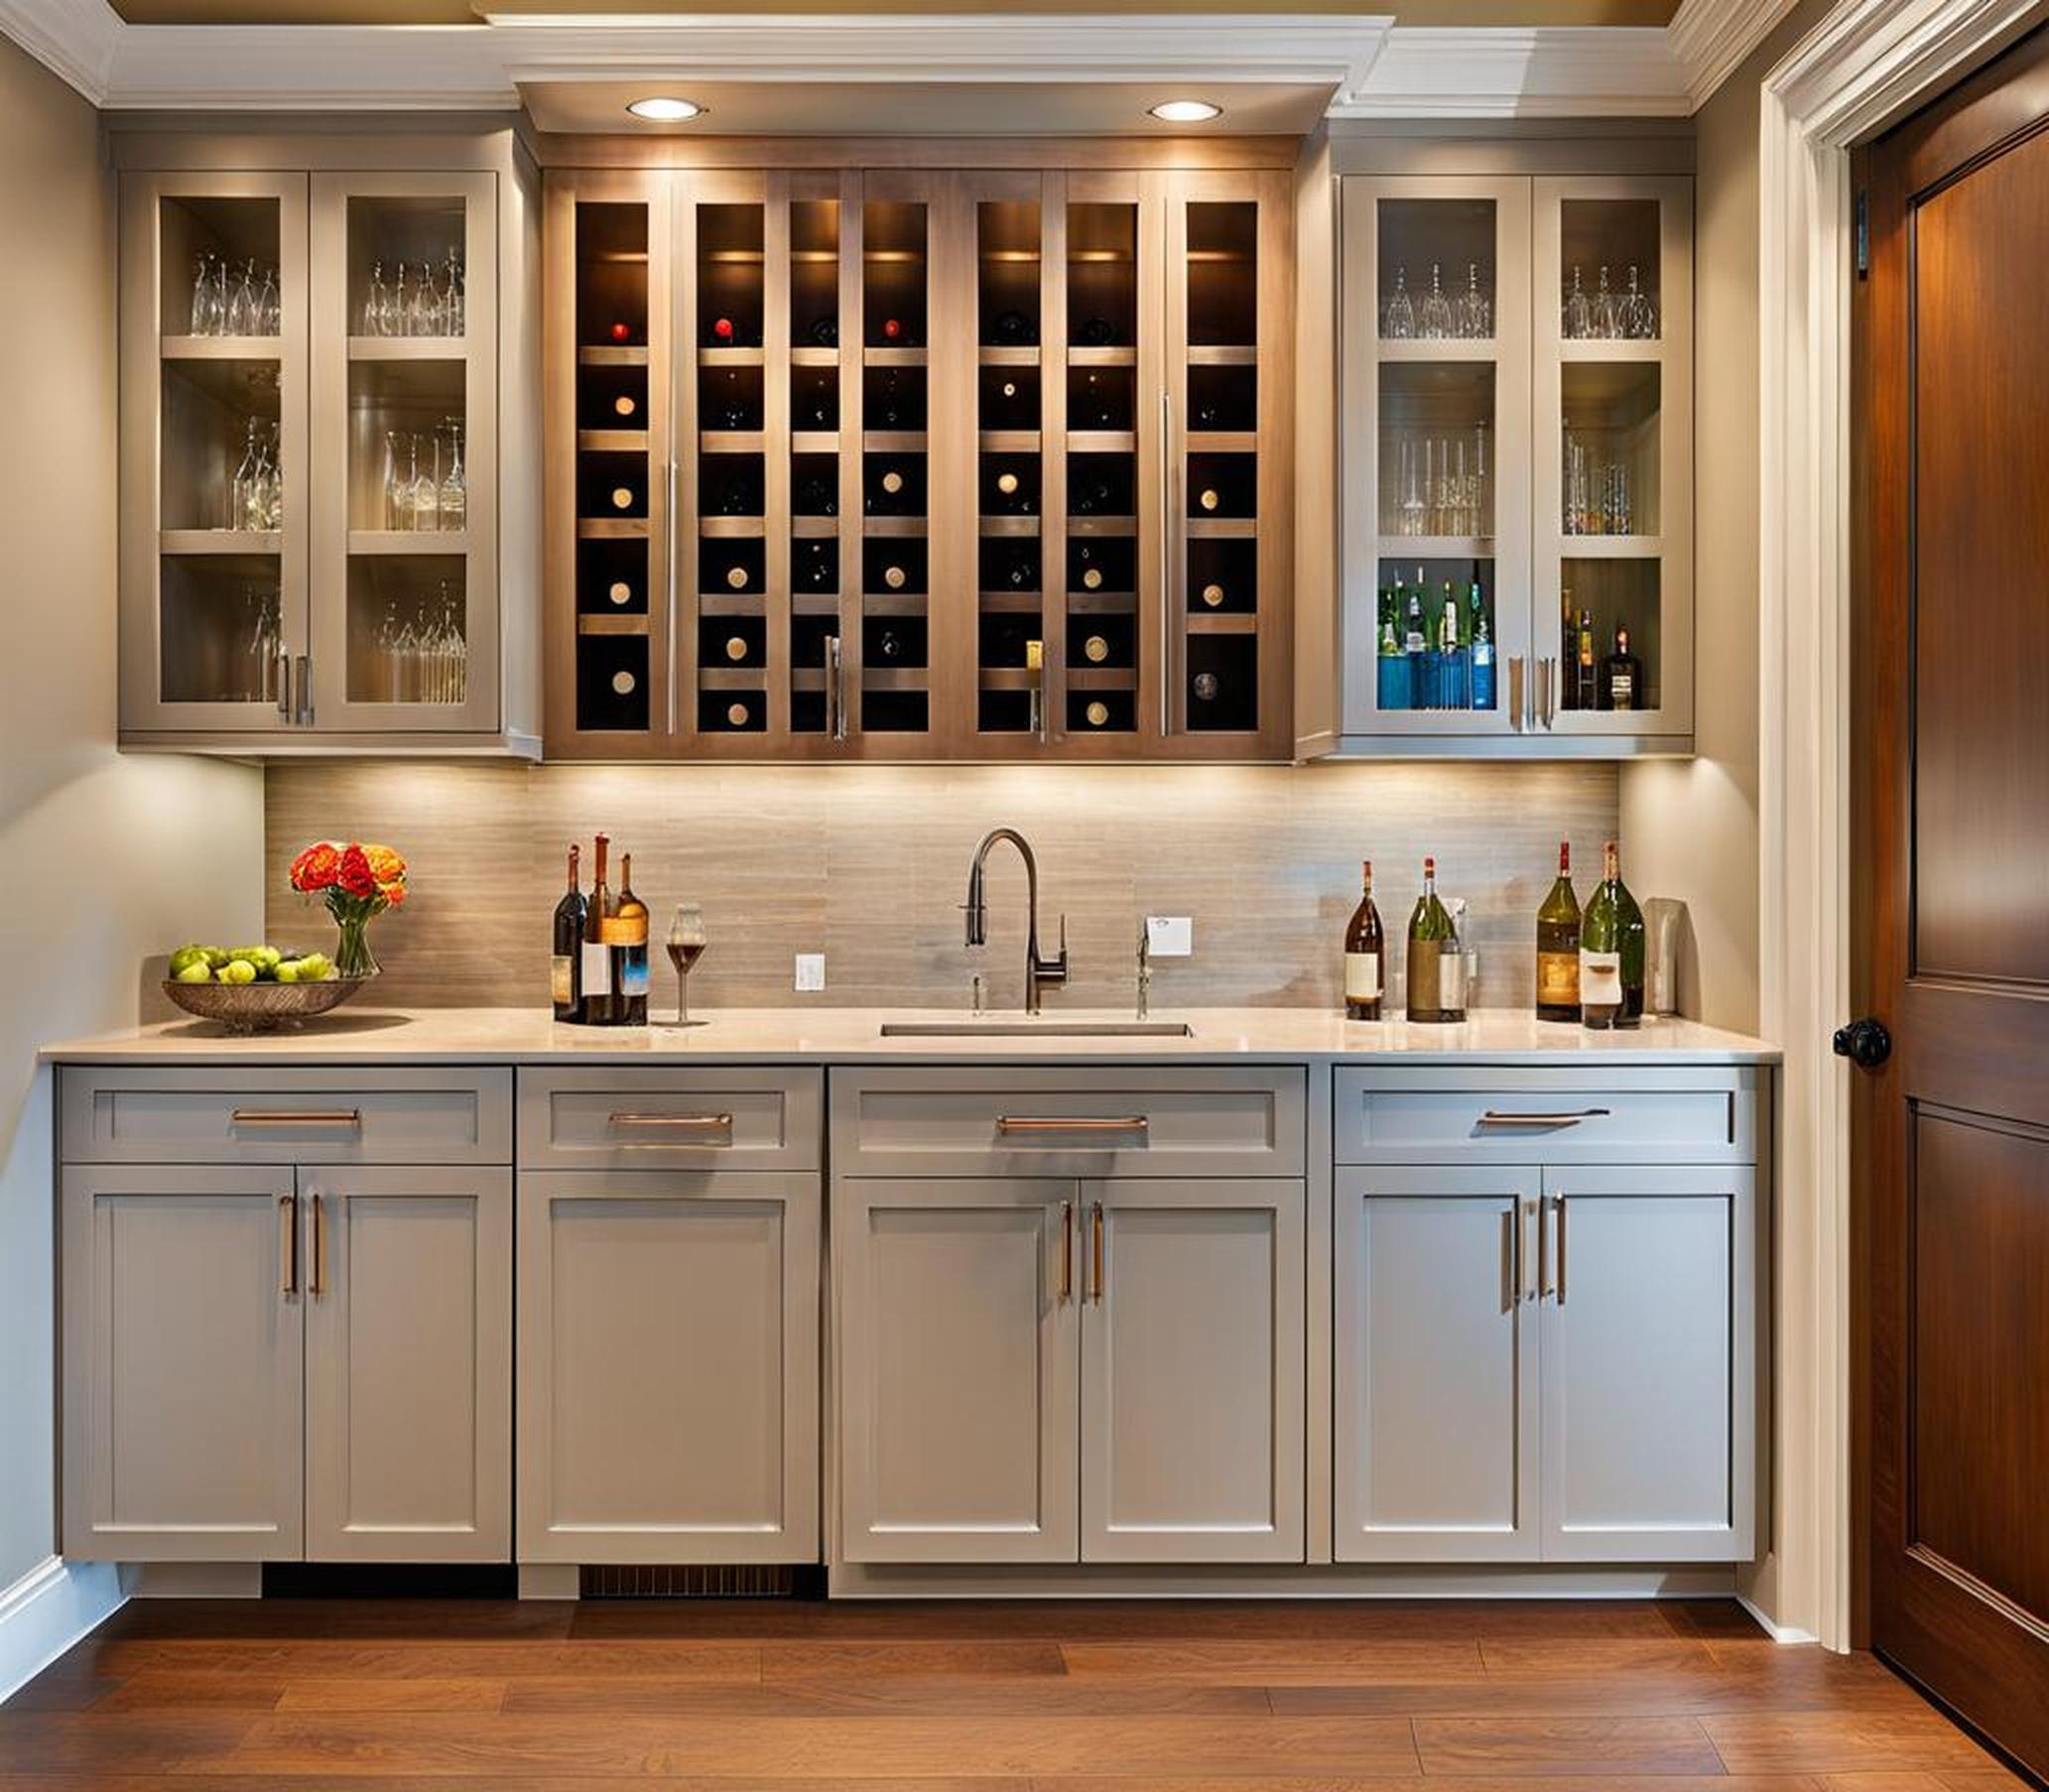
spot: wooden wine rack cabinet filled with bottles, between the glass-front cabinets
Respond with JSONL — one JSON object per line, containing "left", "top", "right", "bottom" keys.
{"left": 545, "top": 146, "right": 1293, "bottom": 760}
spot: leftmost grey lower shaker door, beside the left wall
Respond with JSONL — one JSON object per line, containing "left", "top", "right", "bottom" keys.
{"left": 64, "top": 1165, "right": 306, "bottom": 1563}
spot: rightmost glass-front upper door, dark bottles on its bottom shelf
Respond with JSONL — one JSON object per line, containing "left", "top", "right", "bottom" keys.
{"left": 1533, "top": 177, "right": 1693, "bottom": 741}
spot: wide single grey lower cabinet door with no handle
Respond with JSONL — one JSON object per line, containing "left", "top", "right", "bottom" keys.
{"left": 518, "top": 1170, "right": 820, "bottom": 1563}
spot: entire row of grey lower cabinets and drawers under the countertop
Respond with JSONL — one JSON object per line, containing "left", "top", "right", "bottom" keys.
{"left": 60, "top": 1061, "right": 1770, "bottom": 1592}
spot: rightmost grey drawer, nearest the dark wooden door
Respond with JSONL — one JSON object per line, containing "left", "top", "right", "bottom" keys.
{"left": 1334, "top": 1065, "right": 1760, "bottom": 1163}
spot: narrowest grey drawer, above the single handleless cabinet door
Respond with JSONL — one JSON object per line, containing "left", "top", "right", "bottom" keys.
{"left": 518, "top": 1067, "right": 824, "bottom": 1170}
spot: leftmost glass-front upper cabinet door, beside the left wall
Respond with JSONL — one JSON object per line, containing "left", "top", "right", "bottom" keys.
{"left": 119, "top": 172, "right": 310, "bottom": 735}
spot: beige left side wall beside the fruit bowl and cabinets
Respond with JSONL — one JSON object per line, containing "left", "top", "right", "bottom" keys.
{"left": 0, "top": 39, "right": 262, "bottom": 1590}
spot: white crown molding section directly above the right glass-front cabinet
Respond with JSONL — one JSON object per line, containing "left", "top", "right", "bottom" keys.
{"left": 1330, "top": 27, "right": 1693, "bottom": 119}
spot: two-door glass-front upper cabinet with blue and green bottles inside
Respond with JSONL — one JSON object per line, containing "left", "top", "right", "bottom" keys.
{"left": 1301, "top": 146, "right": 1693, "bottom": 758}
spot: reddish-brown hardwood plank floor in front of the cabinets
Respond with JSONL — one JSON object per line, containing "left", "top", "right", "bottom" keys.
{"left": 0, "top": 1600, "right": 2020, "bottom": 1792}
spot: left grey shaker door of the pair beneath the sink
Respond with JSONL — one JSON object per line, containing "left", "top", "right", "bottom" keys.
{"left": 832, "top": 1178, "right": 1082, "bottom": 1563}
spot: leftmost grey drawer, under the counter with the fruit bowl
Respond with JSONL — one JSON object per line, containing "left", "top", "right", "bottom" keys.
{"left": 64, "top": 1065, "right": 512, "bottom": 1163}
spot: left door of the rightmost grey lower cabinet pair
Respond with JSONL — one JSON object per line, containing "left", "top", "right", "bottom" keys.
{"left": 1334, "top": 1165, "right": 1539, "bottom": 1563}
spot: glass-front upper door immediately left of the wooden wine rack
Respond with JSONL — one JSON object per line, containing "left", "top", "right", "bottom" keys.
{"left": 310, "top": 172, "right": 500, "bottom": 733}
